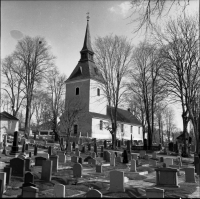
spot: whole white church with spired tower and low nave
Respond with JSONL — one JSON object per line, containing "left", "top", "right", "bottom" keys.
{"left": 61, "top": 19, "right": 143, "bottom": 141}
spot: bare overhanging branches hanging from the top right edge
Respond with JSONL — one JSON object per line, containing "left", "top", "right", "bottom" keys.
{"left": 129, "top": 0, "right": 191, "bottom": 32}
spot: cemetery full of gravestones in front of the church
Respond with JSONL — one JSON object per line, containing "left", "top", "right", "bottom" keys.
{"left": 0, "top": 132, "right": 200, "bottom": 198}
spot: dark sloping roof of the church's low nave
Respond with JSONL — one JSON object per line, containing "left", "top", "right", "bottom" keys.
{"left": 90, "top": 106, "right": 142, "bottom": 126}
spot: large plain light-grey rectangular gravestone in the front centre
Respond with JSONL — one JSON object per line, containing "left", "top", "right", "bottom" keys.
{"left": 110, "top": 171, "right": 125, "bottom": 192}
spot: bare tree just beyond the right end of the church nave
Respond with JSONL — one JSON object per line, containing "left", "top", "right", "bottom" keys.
{"left": 128, "top": 42, "right": 167, "bottom": 147}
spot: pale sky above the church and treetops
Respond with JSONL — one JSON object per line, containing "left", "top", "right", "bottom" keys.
{"left": 1, "top": 0, "right": 199, "bottom": 129}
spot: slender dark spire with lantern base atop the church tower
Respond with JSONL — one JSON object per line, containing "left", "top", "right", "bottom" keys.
{"left": 80, "top": 13, "right": 94, "bottom": 62}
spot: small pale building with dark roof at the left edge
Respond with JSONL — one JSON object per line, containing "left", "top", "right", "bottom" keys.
{"left": 0, "top": 111, "right": 19, "bottom": 142}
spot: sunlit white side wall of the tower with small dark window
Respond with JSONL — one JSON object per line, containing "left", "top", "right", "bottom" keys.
{"left": 89, "top": 79, "right": 107, "bottom": 115}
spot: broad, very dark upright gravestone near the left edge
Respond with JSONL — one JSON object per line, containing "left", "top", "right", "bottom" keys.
{"left": 10, "top": 158, "right": 25, "bottom": 177}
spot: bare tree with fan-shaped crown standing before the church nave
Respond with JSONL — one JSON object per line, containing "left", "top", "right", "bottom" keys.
{"left": 95, "top": 35, "right": 133, "bottom": 148}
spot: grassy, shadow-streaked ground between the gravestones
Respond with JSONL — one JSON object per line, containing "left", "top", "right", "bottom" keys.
{"left": 0, "top": 140, "right": 200, "bottom": 198}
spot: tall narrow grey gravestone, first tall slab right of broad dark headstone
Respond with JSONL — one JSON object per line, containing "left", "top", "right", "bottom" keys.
{"left": 41, "top": 160, "right": 53, "bottom": 182}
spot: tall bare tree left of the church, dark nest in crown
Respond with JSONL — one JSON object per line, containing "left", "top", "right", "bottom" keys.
{"left": 14, "top": 36, "right": 54, "bottom": 137}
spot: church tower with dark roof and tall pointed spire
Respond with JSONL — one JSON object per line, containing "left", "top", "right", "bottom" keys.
{"left": 65, "top": 16, "right": 107, "bottom": 136}
